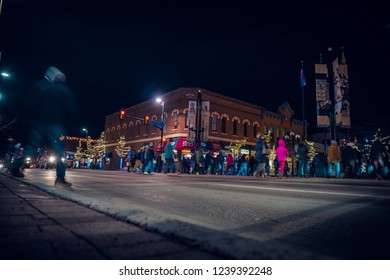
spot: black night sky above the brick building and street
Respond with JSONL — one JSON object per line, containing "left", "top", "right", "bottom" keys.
{"left": 0, "top": 0, "right": 390, "bottom": 142}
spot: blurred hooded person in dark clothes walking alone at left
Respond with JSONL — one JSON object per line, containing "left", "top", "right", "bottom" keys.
{"left": 28, "top": 67, "right": 75, "bottom": 187}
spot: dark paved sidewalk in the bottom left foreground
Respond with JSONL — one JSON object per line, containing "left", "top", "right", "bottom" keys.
{"left": 0, "top": 173, "right": 224, "bottom": 260}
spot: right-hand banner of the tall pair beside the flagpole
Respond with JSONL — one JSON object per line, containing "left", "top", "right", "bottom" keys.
{"left": 333, "top": 59, "right": 351, "bottom": 128}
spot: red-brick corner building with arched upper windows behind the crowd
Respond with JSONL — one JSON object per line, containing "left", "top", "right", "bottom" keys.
{"left": 105, "top": 88, "right": 303, "bottom": 169}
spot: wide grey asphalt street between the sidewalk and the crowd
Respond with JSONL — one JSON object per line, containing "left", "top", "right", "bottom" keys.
{"left": 1, "top": 169, "right": 390, "bottom": 259}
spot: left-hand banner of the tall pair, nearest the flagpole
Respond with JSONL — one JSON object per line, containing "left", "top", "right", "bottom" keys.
{"left": 315, "top": 64, "right": 332, "bottom": 127}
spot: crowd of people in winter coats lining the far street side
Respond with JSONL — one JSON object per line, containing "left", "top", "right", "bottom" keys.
{"left": 121, "top": 134, "right": 390, "bottom": 179}
